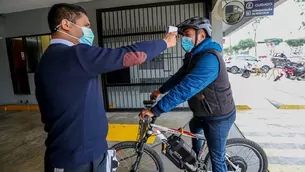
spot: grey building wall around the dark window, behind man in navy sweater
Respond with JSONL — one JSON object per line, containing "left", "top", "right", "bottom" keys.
{"left": 0, "top": 0, "right": 222, "bottom": 104}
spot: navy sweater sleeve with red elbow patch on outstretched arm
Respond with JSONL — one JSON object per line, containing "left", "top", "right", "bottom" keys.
{"left": 75, "top": 40, "right": 167, "bottom": 75}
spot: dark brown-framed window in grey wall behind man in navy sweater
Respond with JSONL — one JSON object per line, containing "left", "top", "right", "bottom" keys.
{"left": 6, "top": 35, "right": 51, "bottom": 94}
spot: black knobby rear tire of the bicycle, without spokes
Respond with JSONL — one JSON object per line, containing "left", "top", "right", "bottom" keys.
{"left": 204, "top": 138, "right": 268, "bottom": 172}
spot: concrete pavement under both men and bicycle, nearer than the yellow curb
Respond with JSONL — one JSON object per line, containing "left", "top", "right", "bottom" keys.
{"left": 0, "top": 109, "right": 305, "bottom": 172}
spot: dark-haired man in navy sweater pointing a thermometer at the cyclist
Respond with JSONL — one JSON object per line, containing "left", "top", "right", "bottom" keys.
{"left": 35, "top": 3, "right": 177, "bottom": 172}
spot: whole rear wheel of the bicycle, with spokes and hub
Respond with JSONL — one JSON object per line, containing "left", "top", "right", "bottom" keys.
{"left": 204, "top": 138, "right": 268, "bottom": 172}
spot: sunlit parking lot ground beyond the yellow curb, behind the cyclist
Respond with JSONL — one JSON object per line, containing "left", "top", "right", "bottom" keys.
{"left": 229, "top": 71, "right": 305, "bottom": 109}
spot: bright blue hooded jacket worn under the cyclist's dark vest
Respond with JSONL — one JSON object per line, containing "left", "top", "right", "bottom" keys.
{"left": 152, "top": 38, "right": 222, "bottom": 116}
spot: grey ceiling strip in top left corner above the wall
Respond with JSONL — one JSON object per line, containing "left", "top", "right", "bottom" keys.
{"left": 0, "top": 0, "right": 92, "bottom": 14}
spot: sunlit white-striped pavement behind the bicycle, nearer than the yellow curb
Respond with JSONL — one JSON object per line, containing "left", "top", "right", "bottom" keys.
{"left": 236, "top": 110, "right": 305, "bottom": 172}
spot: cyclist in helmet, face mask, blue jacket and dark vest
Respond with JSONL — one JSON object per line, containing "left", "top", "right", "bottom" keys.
{"left": 139, "top": 17, "right": 236, "bottom": 172}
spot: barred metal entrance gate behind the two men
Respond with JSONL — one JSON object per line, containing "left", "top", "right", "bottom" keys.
{"left": 97, "top": 1, "right": 208, "bottom": 111}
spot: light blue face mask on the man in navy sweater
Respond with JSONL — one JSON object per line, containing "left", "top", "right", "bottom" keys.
{"left": 57, "top": 22, "right": 94, "bottom": 45}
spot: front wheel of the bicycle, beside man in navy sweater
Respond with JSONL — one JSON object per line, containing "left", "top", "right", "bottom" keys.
{"left": 112, "top": 142, "right": 164, "bottom": 172}
